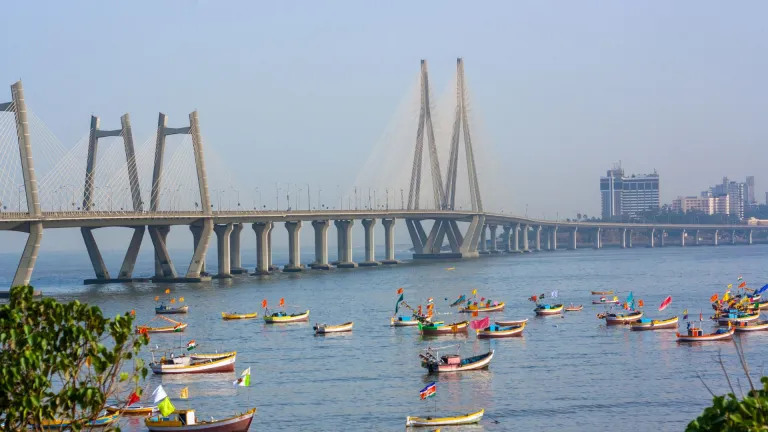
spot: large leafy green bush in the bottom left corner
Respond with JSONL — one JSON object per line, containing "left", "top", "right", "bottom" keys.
{"left": 0, "top": 286, "right": 149, "bottom": 431}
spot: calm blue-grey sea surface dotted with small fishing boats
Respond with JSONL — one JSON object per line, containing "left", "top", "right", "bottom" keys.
{"left": 0, "top": 245, "right": 768, "bottom": 431}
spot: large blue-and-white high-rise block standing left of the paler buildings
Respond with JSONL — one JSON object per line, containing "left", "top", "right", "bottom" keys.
{"left": 600, "top": 164, "right": 659, "bottom": 219}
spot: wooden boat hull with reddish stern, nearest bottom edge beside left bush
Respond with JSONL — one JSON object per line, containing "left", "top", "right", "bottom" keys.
{"left": 144, "top": 408, "right": 256, "bottom": 432}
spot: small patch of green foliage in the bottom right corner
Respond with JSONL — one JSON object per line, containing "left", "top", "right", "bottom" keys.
{"left": 685, "top": 377, "right": 768, "bottom": 432}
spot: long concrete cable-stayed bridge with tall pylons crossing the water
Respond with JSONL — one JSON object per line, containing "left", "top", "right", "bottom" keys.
{"left": 0, "top": 59, "right": 768, "bottom": 286}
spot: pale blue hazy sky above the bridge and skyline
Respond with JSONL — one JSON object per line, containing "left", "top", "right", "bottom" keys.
{"left": 0, "top": 0, "right": 768, "bottom": 253}
